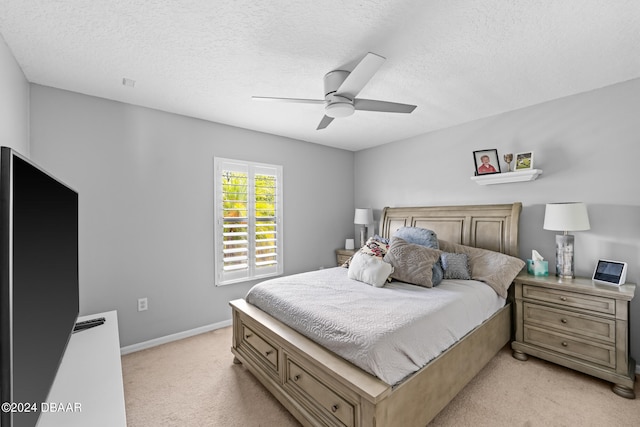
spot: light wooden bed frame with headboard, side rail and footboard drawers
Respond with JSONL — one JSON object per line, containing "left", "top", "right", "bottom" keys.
{"left": 230, "top": 203, "right": 522, "bottom": 427}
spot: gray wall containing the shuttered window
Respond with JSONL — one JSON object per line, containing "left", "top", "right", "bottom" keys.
{"left": 30, "top": 85, "right": 354, "bottom": 346}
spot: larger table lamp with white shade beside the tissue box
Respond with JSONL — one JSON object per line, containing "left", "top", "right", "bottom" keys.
{"left": 543, "top": 202, "right": 591, "bottom": 279}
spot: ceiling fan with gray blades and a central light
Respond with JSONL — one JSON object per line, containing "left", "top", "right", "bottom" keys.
{"left": 252, "top": 52, "right": 416, "bottom": 130}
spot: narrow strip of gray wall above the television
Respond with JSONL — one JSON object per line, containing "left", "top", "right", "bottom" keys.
{"left": 0, "top": 35, "right": 29, "bottom": 157}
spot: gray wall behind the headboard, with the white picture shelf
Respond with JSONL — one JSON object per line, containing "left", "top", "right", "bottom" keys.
{"left": 355, "top": 79, "right": 640, "bottom": 359}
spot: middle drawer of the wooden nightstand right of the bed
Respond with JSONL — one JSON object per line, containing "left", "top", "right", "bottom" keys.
{"left": 524, "top": 302, "right": 616, "bottom": 343}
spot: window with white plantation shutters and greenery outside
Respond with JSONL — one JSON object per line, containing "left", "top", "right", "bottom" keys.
{"left": 214, "top": 157, "right": 283, "bottom": 285}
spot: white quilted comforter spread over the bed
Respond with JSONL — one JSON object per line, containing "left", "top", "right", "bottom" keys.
{"left": 246, "top": 267, "right": 505, "bottom": 385}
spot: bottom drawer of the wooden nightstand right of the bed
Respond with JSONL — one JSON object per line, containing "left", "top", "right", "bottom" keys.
{"left": 524, "top": 324, "right": 616, "bottom": 368}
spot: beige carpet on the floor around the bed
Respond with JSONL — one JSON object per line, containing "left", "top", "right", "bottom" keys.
{"left": 122, "top": 327, "right": 640, "bottom": 427}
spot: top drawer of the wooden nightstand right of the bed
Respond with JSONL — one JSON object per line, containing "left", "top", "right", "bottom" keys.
{"left": 522, "top": 285, "right": 616, "bottom": 314}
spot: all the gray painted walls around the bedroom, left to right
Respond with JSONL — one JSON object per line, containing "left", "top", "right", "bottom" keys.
{"left": 6, "top": 33, "right": 640, "bottom": 359}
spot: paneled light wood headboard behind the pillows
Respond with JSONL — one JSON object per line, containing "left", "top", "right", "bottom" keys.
{"left": 380, "top": 202, "right": 522, "bottom": 257}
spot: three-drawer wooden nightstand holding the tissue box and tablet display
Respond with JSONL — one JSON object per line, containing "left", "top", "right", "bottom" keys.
{"left": 511, "top": 273, "right": 636, "bottom": 399}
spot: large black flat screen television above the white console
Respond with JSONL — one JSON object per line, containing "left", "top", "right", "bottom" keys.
{"left": 0, "top": 147, "right": 79, "bottom": 427}
